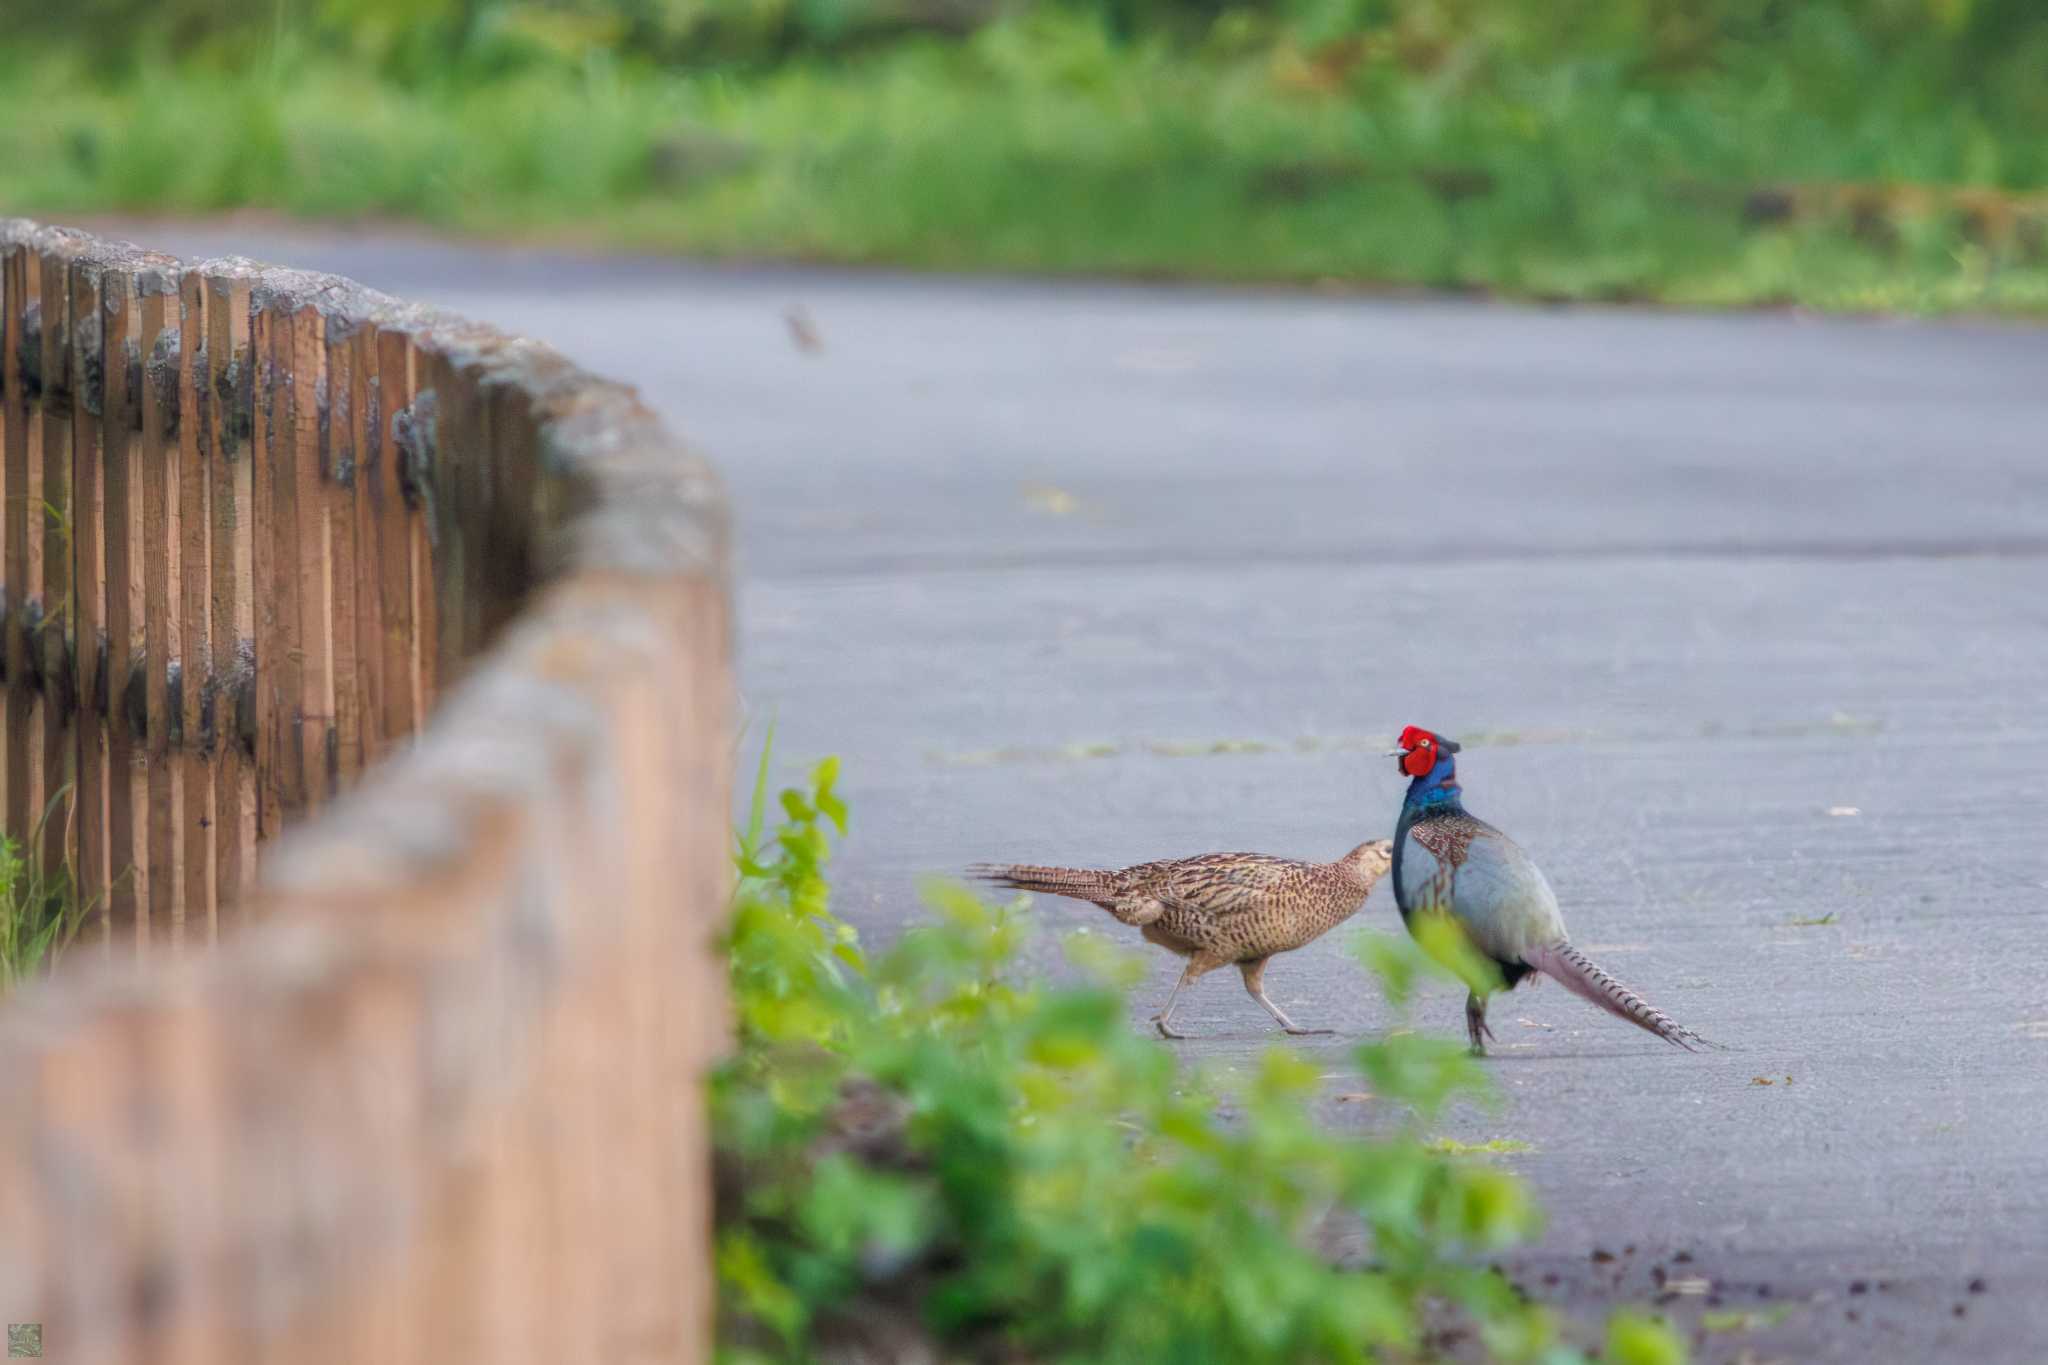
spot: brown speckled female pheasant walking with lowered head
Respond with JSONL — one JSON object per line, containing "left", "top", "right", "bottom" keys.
{"left": 967, "top": 839, "right": 1393, "bottom": 1038}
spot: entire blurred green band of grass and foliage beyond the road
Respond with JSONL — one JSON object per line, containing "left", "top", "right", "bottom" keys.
{"left": 0, "top": 0, "right": 2048, "bottom": 311}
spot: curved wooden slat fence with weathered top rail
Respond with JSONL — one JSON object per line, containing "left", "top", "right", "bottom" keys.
{"left": 0, "top": 221, "right": 731, "bottom": 1363}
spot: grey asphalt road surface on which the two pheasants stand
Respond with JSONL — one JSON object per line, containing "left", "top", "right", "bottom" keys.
{"left": 103, "top": 227, "right": 2048, "bottom": 1361}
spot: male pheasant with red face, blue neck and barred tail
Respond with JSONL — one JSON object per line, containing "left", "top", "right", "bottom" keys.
{"left": 1386, "top": 724, "right": 1716, "bottom": 1056}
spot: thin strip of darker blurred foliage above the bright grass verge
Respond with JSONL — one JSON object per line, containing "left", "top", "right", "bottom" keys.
{"left": 28, "top": 0, "right": 2048, "bottom": 83}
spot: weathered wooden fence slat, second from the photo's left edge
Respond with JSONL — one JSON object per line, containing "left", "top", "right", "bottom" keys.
{"left": 37, "top": 250, "right": 73, "bottom": 872}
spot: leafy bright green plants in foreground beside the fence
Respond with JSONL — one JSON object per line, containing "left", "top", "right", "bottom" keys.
{"left": 713, "top": 755, "right": 1683, "bottom": 1365}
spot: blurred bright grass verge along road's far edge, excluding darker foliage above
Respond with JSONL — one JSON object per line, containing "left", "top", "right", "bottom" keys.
{"left": 0, "top": 4, "right": 2048, "bottom": 313}
